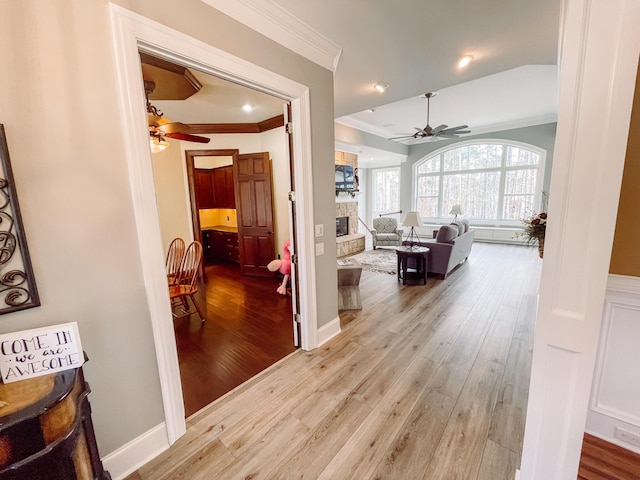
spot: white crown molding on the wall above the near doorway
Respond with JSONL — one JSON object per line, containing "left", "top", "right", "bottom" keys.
{"left": 202, "top": 0, "right": 342, "bottom": 73}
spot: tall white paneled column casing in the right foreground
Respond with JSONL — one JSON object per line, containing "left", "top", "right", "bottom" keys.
{"left": 520, "top": 0, "right": 640, "bottom": 480}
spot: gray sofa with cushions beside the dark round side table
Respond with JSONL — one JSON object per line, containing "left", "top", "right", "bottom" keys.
{"left": 404, "top": 220, "right": 474, "bottom": 279}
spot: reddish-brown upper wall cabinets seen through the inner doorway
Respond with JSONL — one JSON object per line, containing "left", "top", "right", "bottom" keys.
{"left": 195, "top": 165, "right": 236, "bottom": 209}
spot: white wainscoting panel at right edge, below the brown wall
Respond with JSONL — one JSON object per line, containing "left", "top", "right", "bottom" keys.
{"left": 586, "top": 275, "right": 640, "bottom": 453}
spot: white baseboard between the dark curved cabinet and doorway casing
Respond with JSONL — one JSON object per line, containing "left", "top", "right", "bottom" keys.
{"left": 102, "top": 422, "right": 169, "bottom": 480}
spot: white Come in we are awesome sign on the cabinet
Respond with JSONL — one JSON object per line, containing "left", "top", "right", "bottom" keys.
{"left": 0, "top": 322, "right": 84, "bottom": 383}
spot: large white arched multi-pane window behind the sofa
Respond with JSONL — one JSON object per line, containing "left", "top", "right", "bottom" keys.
{"left": 413, "top": 140, "right": 545, "bottom": 225}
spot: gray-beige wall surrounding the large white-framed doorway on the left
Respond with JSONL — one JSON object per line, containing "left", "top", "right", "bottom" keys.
{"left": 0, "top": 0, "right": 337, "bottom": 455}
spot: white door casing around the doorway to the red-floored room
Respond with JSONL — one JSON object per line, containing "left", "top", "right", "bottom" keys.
{"left": 109, "top": 4, "right": 317, "bottom": 444}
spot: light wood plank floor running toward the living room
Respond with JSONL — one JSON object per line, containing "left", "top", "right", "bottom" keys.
{"left": 128, "top": 243, "right": 542, "bottom": 480}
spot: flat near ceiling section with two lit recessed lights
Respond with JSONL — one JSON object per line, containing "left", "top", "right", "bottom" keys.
{"left": 273, "top": 0, "right": 560, "bottom": 117}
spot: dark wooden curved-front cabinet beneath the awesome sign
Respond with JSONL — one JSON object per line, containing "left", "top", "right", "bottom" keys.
{"left": 0, "top": 368, "right": 111, "bottom": 480}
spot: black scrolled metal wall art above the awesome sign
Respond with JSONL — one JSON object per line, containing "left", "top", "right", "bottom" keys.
{"left": 0, "top": 123, "right": 40, "bottom": 315}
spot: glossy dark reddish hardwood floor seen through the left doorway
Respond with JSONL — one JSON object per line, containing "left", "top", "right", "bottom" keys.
{"left": 174, "top": 261, "right": 295, "bottom": 417}
